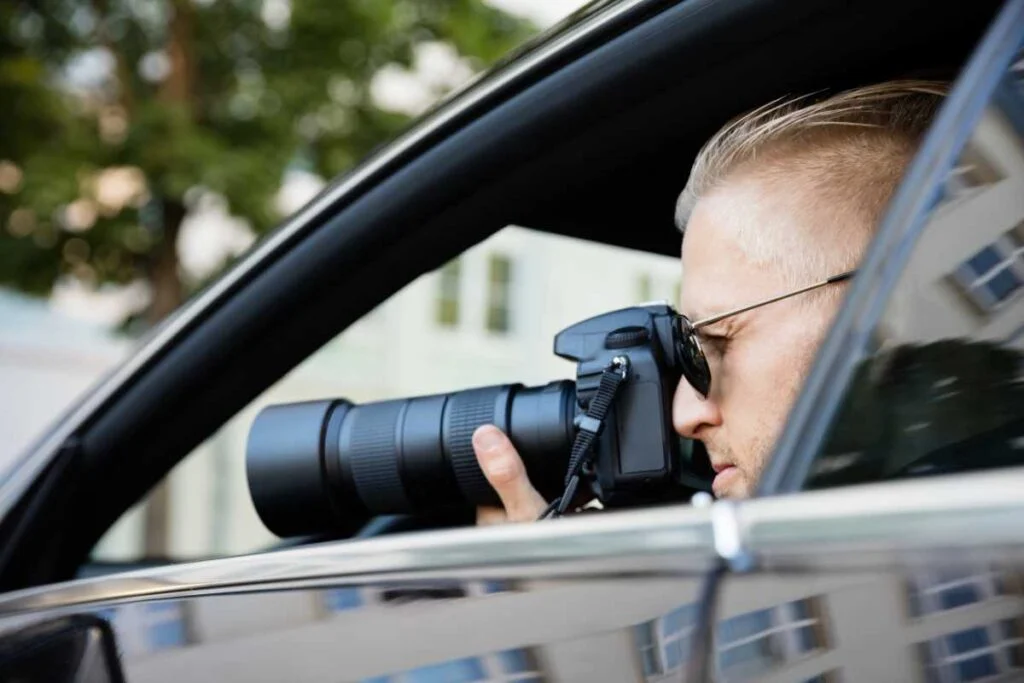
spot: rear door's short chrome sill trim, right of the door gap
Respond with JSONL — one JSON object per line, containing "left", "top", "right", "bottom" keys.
{"left": 739, "top": 468, "right": 1024, "bottom": 569}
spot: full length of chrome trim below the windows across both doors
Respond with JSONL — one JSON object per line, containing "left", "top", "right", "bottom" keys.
{"left": 0, "top": 468, "right": 1024, "bottom": 617}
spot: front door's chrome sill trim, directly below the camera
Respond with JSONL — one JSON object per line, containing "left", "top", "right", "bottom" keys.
{"left": 0, "top": 506, "right": 717, "bottom": 617}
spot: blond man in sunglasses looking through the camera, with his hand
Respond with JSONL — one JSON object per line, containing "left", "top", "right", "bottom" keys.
{"left": 473, "top": 81, "right": 946, "bottom": 523}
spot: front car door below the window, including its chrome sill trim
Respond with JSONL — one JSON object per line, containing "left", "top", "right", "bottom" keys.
{"left": 0, "top": 507, "right": 717, "bottom": 683}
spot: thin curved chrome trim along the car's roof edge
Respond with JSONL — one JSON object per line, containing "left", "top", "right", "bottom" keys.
{"left": 0, "top": 0, "right": 657, "bottom": 519}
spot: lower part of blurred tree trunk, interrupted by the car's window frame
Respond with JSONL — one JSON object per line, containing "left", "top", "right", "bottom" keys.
{"left": 144, "top": 200, "right": 185, "bottom": 558}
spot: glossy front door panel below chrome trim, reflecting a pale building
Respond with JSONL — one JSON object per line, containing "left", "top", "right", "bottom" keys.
{"left": 91, "top": 573, "right": 700, "bottom": 683}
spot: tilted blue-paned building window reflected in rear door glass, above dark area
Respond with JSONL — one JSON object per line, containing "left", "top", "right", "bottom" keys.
{"left": 952, "top": 223, "right": 1024, "bottom": 313}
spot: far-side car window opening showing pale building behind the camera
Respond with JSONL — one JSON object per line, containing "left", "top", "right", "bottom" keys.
{"left": 93, "top": 226, "right": 680, "bottom": 562}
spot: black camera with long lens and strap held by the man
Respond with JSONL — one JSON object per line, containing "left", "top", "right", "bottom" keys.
{"left": 246, "top": 303, "right": 713, "bottom": 537}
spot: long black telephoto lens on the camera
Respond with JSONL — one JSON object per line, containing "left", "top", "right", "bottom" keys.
{"left": 246, "top": 380, "right": 577, "bottom": 537}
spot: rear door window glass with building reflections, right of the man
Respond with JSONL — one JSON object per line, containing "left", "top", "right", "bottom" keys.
{"left": 806, "top": 50, "right": 1024, "bottom": 493}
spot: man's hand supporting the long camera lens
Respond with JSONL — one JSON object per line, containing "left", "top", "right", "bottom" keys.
{"left": 473, "top": 425, "right": 548, "bottom": 525}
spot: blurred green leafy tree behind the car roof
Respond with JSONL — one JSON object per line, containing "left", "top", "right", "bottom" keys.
{"left": 0, "top": 0, "right": 534, "bottom": 554}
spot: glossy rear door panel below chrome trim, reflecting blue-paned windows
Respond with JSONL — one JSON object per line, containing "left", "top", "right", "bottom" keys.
{"left": 712, "top": 561, "right": 1024, "bottom": 683}
